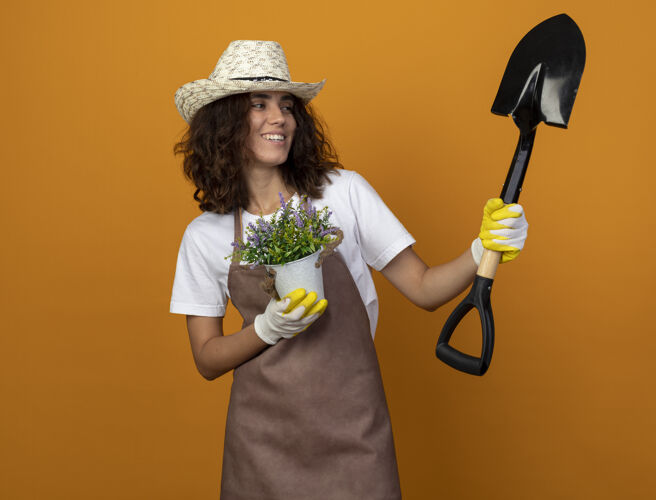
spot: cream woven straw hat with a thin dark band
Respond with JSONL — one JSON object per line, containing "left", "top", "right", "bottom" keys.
{"left": 175, "top": 40, "right": 326, "bottom": 123}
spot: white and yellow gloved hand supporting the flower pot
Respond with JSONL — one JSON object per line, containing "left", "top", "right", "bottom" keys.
{"left": 253, "top": 288, "right": 328, "bottom": 345}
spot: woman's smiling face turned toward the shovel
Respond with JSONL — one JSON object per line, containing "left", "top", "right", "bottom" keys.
{"left": 246, "top": 91, "right": 296, "bottom": 172}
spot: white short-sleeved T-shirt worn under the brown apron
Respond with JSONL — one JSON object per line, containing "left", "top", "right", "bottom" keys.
{"left": 170, "top": 170, "right": 415, "bottom": 336}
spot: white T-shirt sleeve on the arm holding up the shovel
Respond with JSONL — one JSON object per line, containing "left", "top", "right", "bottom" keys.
{"left": 349, "top": 172, "right": 415, "bottom": 271}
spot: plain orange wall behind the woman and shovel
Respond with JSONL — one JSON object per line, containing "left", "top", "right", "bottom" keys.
{"left": 0, "top": 0, "right": 656, "bottom": 500}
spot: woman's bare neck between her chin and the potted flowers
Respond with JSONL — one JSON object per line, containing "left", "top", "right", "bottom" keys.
{"left": 244, "top": 167, "right": 294, "bottom": 215}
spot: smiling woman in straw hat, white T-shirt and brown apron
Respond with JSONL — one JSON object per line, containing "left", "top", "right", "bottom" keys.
{"left": 171, "top": 40, "right": 527, "bottom": 500}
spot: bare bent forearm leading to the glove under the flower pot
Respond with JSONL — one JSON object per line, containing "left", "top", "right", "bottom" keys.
{"left": 198, "top": 324, "right": 269, "bottom": 380}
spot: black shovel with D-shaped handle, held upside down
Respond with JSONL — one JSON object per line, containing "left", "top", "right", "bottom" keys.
{"left": 435, "top": 14, "right": 585, "bottom": 375}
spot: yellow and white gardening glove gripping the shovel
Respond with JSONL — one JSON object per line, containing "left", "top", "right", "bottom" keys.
{"left": 472, "top": 198, "right": 528, "bottom": 264}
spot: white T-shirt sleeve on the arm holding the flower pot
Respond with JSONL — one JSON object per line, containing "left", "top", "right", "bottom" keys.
{"left": 169, "top": 227, "right": 227, "bottom": 317}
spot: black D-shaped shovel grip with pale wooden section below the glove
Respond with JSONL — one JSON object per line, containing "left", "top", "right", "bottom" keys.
{"left": 435, "top": 249, "right": 501, "bottom": 375}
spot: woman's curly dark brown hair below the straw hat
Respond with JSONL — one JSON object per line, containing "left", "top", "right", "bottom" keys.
{"left": 173, "top": 94, "right": 342, "bottom": 214}
